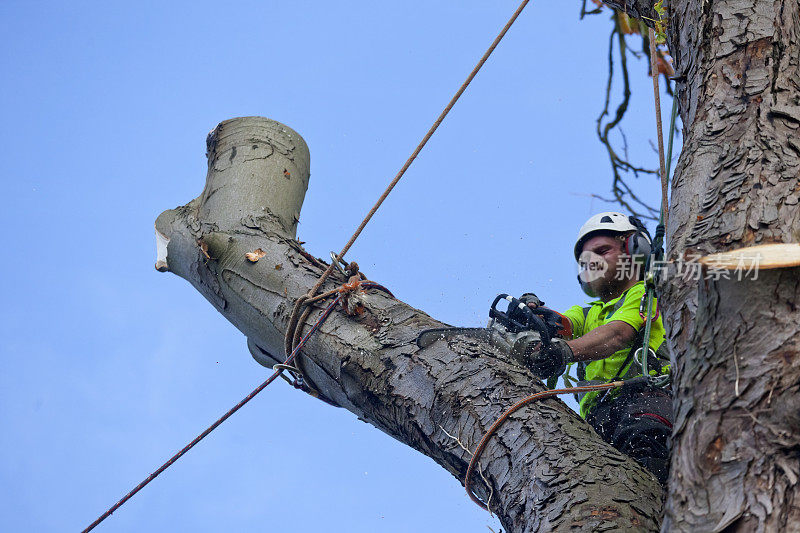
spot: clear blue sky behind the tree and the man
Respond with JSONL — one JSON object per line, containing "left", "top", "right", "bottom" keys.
{"left": 0, "top": 0, "right": 670, "bottom": 532}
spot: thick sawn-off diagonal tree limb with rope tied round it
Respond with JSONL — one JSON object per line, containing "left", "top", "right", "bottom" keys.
{"left": 156, "top": 118, "right": 661, "bottom": 531}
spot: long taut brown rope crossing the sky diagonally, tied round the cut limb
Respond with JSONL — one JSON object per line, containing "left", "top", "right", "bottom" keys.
{"left": 83, "top": 0, "right": 530, "bottom": 533}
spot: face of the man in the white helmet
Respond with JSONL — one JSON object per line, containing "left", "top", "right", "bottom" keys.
{"left": 578, "top": 235, "right": 630, "bottom": 297}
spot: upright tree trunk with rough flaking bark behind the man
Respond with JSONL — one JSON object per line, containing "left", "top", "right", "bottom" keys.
{"left": 660, "top": 0, "right": 800, "bottom": 532}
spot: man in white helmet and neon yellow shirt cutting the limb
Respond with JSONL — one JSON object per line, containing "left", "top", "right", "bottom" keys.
{"left": 520, "top": 212, "right": 673, "bottom": 483}
